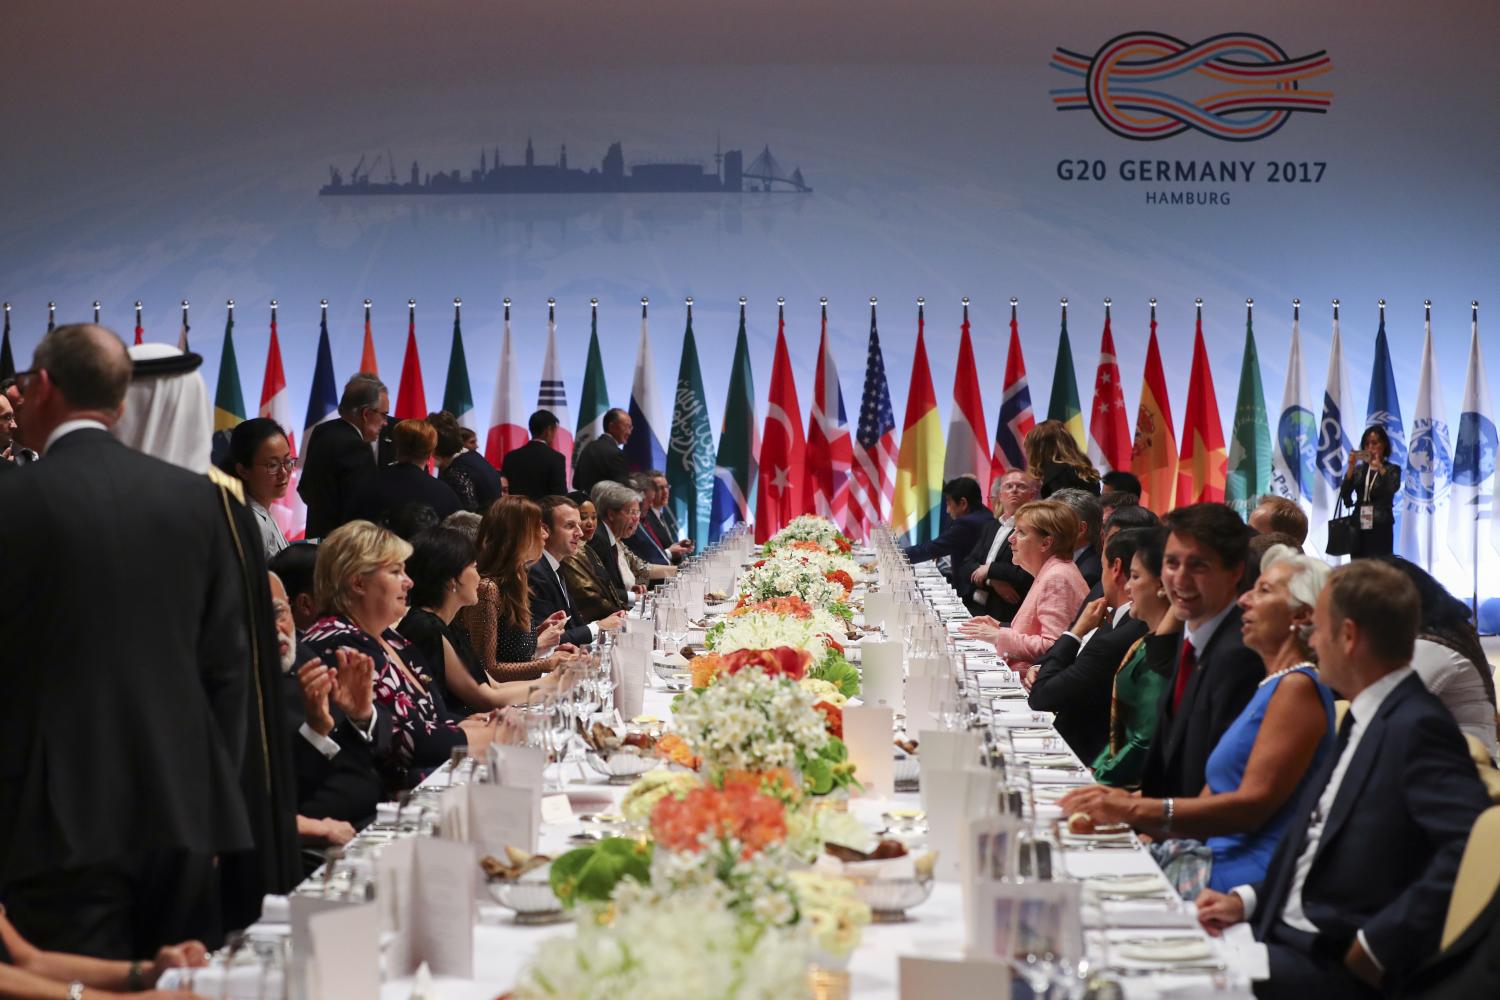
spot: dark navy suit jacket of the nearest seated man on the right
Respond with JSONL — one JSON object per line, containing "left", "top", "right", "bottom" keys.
{"left": 1254, "top": 675, "right": 1490, "bottom": 996}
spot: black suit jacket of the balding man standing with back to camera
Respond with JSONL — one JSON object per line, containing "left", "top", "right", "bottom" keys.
{"left": 0, "top": 429, "right": 252, "bottom": 885}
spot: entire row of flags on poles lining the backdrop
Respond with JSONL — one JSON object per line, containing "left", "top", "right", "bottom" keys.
{"left": 0, "top": 298, "right": 1500, "bottom": 581}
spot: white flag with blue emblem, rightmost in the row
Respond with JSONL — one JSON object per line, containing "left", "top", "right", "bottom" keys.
{"left": 1448, "top": 303, "right": 1500, "bottom": 575}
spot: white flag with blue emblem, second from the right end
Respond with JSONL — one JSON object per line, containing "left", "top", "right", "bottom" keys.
{"left": 1401, "top": 303, "right": 1454, "bottom": 573}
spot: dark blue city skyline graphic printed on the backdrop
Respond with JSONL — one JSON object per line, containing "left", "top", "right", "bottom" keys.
{"left": 318, "top": 138, "right": 813, "bottom": 195}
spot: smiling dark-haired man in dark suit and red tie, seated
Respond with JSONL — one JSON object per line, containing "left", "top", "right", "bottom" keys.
{"left": 1142, "top": 504, "right": 1266, "bottom": 799}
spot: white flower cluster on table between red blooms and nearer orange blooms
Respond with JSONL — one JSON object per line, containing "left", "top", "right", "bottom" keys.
{"left": 672, "top": 668, "right": 828, "bottom": 774}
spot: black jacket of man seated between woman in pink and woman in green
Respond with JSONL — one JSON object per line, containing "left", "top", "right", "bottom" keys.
{"left": 1028, "top": 605, "right": 1146, "bottom": 762}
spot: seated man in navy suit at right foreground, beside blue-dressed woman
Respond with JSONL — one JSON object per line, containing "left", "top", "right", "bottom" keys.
{"left": 1197, "top": 559, "right": 1490, "bottom": 1000}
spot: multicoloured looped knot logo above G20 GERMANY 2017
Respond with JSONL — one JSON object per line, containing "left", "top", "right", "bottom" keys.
{"left": 1050, "top": 31, "right": 1334, "bottom": 142}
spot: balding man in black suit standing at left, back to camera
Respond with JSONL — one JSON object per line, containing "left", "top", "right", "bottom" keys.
{"left": 0, "top": 325, "right": 252, "bottom": 958}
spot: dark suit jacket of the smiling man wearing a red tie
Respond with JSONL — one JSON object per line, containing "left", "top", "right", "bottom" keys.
{"left": 1140, "top": 607, "right": 1266, "bottom": 799}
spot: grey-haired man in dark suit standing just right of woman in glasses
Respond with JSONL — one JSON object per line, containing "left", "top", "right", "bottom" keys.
{"left": 297, "top": 372, "right": 390, "bottom": 538}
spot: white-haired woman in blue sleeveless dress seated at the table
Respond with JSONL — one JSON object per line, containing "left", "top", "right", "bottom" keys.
{"left": 1068, "top": 546, "right": 1335, "bottom": 898}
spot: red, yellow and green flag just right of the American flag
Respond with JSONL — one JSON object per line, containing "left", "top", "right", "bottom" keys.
{"left": 891, "top": 298, "right": 944, "bottom": 544}
